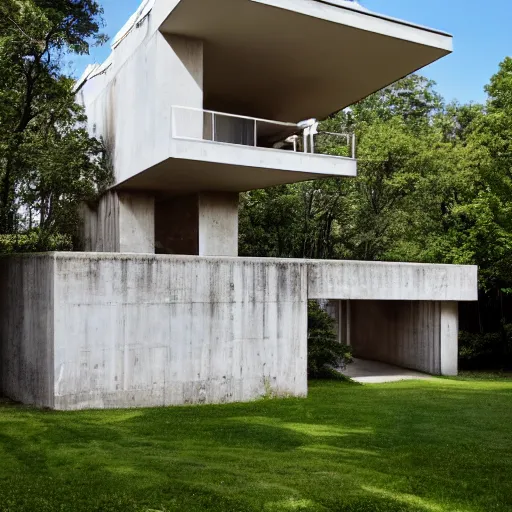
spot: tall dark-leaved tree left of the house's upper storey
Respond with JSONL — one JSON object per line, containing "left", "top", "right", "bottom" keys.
{"left": 0, "top": 0, "right": 109, "bottom": 244}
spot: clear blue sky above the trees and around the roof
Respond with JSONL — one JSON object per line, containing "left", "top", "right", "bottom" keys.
{"left": 71, "top": 0, "right": 512, "bottom": 103}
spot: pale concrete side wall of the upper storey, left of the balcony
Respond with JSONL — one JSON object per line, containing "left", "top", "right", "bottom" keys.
{"left": 77, "top": 33, "right": 203, "bottom": 190}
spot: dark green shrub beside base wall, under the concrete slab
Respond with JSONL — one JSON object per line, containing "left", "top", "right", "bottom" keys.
{"left": 308, "top": 301, "right": 352, "bottom": 379}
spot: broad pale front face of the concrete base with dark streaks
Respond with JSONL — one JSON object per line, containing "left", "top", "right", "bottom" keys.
{"left": 54, "top": 254, "right": 307, "bottom": 409}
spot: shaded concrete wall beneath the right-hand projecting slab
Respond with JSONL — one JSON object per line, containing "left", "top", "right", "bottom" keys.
{"left": 350, "top": 301, "right": 458, "bottom": 375}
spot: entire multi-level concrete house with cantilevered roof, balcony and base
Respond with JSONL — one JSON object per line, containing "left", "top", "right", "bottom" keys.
{"left": 0, "top": 0, "right": 477, "bottom": 410}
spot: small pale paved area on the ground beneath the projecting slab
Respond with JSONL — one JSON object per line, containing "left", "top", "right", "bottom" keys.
{"left": 342, "top": 359, "right": 433, "bottom": 384}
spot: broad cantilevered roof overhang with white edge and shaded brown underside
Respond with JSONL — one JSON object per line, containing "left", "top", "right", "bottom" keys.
{"left": 160, "top": 0, "right": 453, "bottom": 122}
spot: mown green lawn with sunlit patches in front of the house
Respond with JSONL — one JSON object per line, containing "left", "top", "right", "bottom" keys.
{"left": 0, "top": 376, "right": 512, "bottom": 512}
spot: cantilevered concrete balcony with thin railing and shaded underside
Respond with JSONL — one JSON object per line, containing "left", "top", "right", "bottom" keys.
{"left": 115, "top": 106, "right": 357, "bottom": 192}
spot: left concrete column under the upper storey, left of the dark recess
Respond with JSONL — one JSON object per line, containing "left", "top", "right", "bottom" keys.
{"left": 81, "top": 191, "right": 155, "bottom": 254}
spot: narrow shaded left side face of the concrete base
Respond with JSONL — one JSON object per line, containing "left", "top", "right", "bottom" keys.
{"left": 0, "top": 255, "right": 54, "bottom": 407}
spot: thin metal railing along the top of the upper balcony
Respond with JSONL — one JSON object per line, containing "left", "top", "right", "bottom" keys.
{"left": 171, "top": 106, "right": 356, "bottom": 159}
